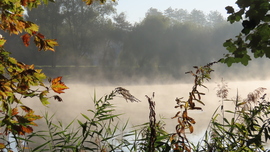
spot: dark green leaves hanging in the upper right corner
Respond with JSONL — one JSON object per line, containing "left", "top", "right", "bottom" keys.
{"left": 221, "top": 0, "right": 270, "bottom": 66}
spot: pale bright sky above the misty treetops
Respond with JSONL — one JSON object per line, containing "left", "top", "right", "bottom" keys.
{"left": 116, "top": 0, "right": 236, "bottom": 23}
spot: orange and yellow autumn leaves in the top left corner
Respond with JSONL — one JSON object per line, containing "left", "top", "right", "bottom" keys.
{"left": 0, "top": 0, "right": 58, "bottom": 51}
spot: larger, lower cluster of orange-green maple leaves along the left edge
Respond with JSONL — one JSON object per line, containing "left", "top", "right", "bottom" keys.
{"left": 0, "top": 41, "right": 67, "bottom": 148}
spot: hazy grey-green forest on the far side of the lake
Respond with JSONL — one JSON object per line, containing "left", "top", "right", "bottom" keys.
{"left": 3, "top": 0, "right": 266, "bottom": 83}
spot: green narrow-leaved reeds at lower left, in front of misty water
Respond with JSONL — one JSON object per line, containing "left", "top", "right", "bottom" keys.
{"left": 13, "top": 89, "right": 127, "bottom": 152}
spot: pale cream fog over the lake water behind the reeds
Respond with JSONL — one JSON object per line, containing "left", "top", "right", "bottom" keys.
{"left": 26, "top": 80, "right": 270, "bottom": 146}
